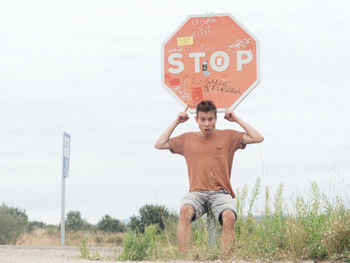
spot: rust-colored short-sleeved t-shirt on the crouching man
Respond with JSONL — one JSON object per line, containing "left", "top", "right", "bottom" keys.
{"left": 169, "top": 130, "right": 245, "bottom": 198}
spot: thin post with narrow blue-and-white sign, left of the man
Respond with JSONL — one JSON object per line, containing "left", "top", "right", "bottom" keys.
{"left": 61, "top": 132, "right": 70, "bottom": 247}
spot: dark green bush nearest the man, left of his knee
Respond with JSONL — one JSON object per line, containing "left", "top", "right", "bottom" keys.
{"left": 128, "top": 205, "right": 169, "bottom": 233}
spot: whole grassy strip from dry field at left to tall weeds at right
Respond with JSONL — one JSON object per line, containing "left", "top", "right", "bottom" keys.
{"left": 17, "top": 178, "right": 350, "bottom": 262}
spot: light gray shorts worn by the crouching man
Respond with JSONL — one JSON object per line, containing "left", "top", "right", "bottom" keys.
{"left": 181, "top": 189, "right": 237, "bottom": 224}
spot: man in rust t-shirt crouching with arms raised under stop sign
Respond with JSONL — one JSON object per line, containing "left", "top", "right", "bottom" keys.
{"left": 155, "top": 101, "right": 264, "bottom": 253}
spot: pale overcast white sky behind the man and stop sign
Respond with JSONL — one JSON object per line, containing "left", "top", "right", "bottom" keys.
{"left": 0, "top": 0, "right": 350, "bottom": 224}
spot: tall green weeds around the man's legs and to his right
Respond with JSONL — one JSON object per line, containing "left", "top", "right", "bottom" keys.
{"left": 118, "top": 178, "right": 350, "bottom": 262}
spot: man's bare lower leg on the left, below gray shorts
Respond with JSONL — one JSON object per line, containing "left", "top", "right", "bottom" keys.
{"left": 177, "top": 205, "right": 194, "bottom": 253}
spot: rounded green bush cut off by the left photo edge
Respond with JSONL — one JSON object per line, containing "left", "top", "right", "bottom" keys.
{"left": 0, "top": 204, "right": 28, "bottom": 245}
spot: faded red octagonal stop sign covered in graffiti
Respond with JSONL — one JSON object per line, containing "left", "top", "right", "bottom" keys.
{"left": 162, "top": 14, "right": 260, "bottom": 113}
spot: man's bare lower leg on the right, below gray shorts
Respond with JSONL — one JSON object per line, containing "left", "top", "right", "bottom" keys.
{"left": 220, "top": 210, "right": 236, "bottom": 255}
